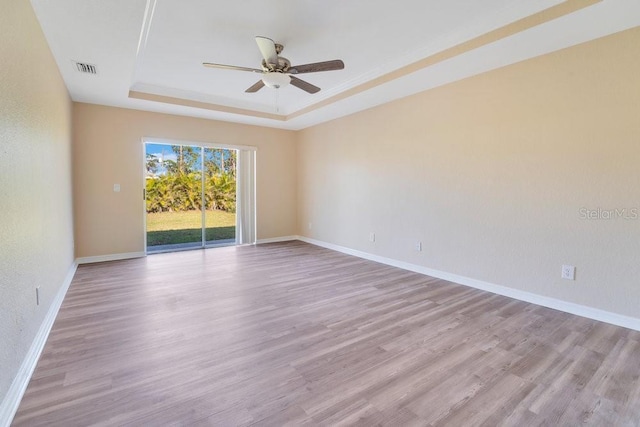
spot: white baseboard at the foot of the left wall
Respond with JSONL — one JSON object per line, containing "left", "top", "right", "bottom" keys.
{"left": 0, "top": 262, "right": 78, "bottom": 427}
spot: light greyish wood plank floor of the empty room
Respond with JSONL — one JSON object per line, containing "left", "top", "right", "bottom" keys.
{"left": 14, "top": 242, "right": 640, "bottom": 427}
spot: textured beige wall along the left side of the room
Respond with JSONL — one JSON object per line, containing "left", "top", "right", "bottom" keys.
{"left": 0, "top": 0, "right": 73, "bottom": 402}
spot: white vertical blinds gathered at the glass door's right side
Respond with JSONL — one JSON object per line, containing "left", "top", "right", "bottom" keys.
{"left": 236, "top": 149, "right": 256, "bottom": 245}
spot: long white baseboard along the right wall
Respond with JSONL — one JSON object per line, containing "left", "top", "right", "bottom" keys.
{"left": 298, "top": 236, "right": 640, "bottom": 331}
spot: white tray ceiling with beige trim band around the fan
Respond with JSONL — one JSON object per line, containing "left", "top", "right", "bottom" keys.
{"left": 31, "top": 0, "right": 640, "bottom": 129}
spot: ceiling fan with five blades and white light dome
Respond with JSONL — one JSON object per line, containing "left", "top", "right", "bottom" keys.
{"left": 202, "top": 36, "right": 344, "bottom": 93}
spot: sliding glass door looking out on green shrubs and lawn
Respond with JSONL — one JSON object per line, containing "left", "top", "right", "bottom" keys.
{"left": 145, "top": 142, "right": 238, "bottom": 252}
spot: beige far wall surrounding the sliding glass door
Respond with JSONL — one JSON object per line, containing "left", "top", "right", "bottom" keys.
{"left": 73, "top": 103, "right": 296, "bottom": 257}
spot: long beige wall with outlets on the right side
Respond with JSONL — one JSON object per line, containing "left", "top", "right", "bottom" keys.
{"left": 298, "top": 29, "right": 640, "bottom": 318}
